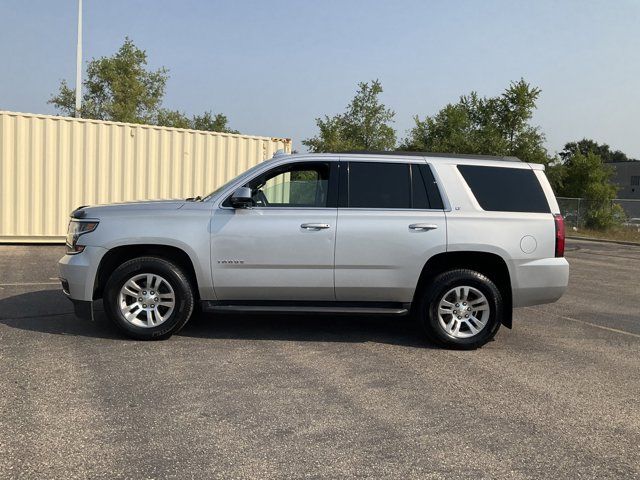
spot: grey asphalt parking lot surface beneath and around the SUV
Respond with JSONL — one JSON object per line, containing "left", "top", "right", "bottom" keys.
{"left": 0, "top": 241, "right": 640, "bottom": 479}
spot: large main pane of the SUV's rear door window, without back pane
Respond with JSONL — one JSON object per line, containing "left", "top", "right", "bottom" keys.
{"left": 349, "top": 162, "right": 411, "bottom": 208}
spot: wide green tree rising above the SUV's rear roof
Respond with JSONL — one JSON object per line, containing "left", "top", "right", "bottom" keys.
{"left": 400, "top": 79, "right": 551, "bottom": 164}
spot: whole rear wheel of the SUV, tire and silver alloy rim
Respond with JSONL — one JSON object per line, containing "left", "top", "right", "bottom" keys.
{"left": 418, "top": 270, "right": 503, "bottom": 349}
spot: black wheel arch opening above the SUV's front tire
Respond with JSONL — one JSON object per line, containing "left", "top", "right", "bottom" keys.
{"left": 93, "top": 244, "right": 198, "bottom": 300}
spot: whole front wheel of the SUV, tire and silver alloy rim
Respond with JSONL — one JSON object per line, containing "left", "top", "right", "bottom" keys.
{"left": 103, "top": 257, "right": 194, "bottom": 340}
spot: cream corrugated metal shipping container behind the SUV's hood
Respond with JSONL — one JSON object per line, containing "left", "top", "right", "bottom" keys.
{"left": 0, "top": 111, "right": 291, "bottom": 243}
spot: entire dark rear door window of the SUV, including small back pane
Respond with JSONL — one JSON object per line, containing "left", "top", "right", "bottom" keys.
{"left": 345, "top": 162, "right": 442, "bottom": 210}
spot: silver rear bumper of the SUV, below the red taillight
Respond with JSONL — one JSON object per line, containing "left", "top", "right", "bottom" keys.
{"left": 512, "top": 258, "right": 569, "bottom": 307}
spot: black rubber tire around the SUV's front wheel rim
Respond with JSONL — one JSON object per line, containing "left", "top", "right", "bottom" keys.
{"left": 103, "top": 257, "right": 195, "bottom": 340}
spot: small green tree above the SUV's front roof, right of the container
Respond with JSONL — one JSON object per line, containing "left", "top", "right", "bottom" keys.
{"left": 302, "top": 80, "right": 396, "bottom": 152}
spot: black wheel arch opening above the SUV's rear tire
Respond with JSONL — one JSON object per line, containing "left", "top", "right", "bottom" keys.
{"left": 413, "top": 251, "right": 513, "bottom": 328}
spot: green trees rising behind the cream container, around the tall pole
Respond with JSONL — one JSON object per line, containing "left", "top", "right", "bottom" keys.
{"left": 48, "top": 37, "right": 237, "bottom": 133}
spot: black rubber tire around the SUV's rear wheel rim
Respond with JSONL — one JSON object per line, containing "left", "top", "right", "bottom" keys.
{"left": 416, "top": 269, "right": 504, "bottom": 350}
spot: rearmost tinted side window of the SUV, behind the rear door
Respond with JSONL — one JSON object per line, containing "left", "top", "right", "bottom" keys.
{"left": 458, "top": 165, "right": 551, "bottom": 213}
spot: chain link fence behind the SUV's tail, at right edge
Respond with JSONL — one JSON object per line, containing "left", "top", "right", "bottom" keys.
{"left": 557, "top": 197, "right": 640, "bottom": 228}
